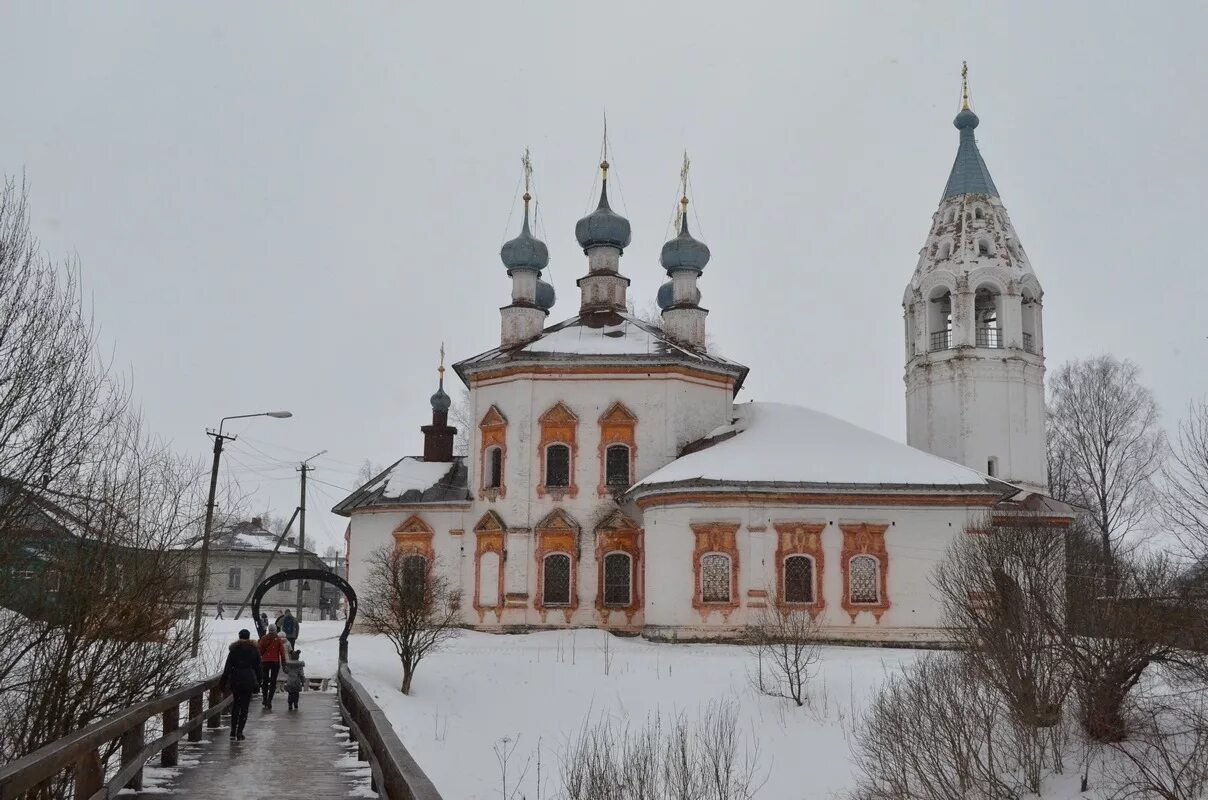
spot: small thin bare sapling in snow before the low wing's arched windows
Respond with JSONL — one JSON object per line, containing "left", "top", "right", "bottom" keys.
{"left": 747, "top": 592, "right": 821, "bottom": 707}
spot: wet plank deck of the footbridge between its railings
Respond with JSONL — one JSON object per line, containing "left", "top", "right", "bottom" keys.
{"left": 134, "top": 691, "right": 376, "bottom": 800}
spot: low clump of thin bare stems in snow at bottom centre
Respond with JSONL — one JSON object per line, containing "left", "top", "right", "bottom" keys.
{"left": 561, "top": 701, "right": 762, "bottom": 800}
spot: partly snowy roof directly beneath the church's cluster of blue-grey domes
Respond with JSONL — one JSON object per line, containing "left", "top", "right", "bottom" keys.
{"left": 454, "top": 312, "right": 747, "bottom": 385}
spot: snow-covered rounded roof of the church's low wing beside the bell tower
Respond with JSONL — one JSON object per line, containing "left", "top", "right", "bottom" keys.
{"left": 633, "top": 402, "right": 998, "bottom": 492}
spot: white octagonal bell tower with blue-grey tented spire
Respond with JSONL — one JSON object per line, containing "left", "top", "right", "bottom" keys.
{"left": 902, "top": 66, "right": 1047, "bottom": 492}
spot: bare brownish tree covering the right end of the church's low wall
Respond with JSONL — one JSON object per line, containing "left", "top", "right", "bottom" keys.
{"left": 933, "top": 517, "right": 1073, "bottom": 727}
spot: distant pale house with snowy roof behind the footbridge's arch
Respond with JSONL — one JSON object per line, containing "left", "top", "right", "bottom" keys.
{"left": 176, "top": 517, "right": 327, "bottom": 620}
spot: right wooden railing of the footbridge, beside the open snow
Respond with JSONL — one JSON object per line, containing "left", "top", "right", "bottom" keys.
{"left": 338, "top": 663, "right": 441, "bottom": 800}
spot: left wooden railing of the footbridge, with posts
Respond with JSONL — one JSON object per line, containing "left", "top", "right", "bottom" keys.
{"left": 0, "top": 674, "right": 231, "bottom": 800}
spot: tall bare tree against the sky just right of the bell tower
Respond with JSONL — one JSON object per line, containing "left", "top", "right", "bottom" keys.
{"left": 1049, "top": 355, "right": 1166, "bottom": 570}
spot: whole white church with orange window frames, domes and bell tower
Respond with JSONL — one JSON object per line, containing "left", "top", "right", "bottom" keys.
{"left": 333, "top": 81, "right": 1073, "bottom": 642}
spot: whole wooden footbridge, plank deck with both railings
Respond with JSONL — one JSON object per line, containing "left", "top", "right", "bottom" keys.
{"left": 0, "top": 663, "right": 441, "bottom": 800}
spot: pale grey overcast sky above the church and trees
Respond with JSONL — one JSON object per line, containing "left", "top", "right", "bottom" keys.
{"left": 0, "top": 1, "right": 1208, "bottom": 544}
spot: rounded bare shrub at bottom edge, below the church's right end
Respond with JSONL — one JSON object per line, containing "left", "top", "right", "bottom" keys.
{"left": 853, "top": 654, "right": 1065, "bottom": 800}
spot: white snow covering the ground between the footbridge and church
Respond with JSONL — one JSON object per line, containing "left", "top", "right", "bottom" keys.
{"left": 198, "top": 607, "right": 1111, "bottom": 800}
